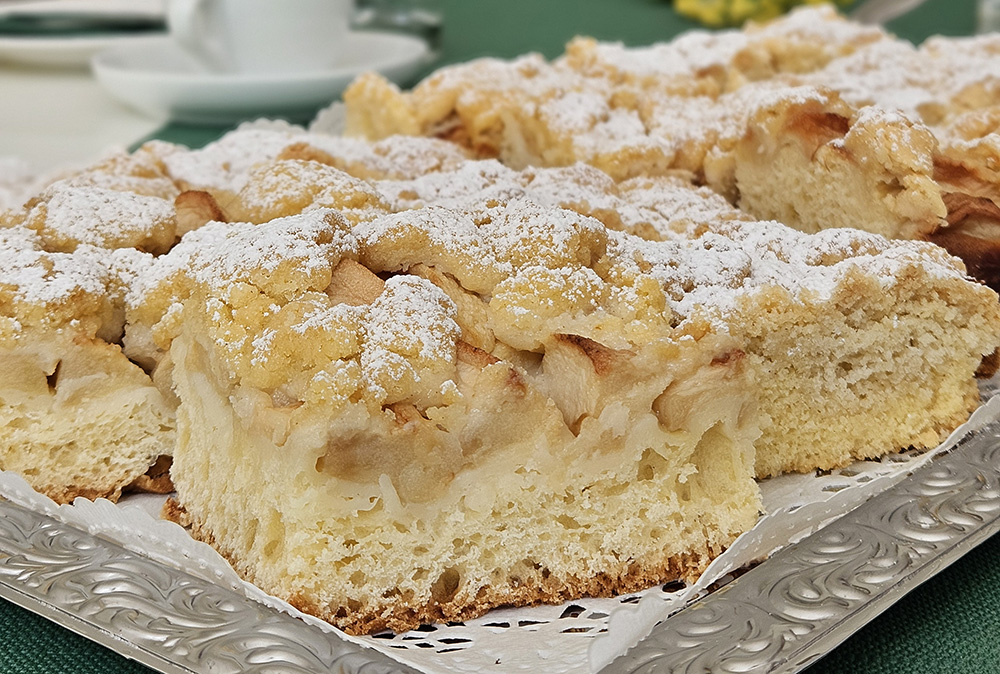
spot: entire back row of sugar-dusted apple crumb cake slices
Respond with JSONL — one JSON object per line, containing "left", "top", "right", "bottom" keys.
{"left": 345, "top": 7, "right": 1000, "bottom": 290}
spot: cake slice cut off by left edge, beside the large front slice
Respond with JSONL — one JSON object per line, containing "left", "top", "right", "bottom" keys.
{"left": 0, "top": 227, "right": 174, "bottom": 503}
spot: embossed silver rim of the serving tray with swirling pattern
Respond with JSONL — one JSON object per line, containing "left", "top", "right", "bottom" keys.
{"left": 0, "top": 414, "right": 1000, "bottom": 674}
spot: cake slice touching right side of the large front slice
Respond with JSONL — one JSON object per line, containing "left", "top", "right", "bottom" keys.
{"left": 608, "top": 221, "right": 1000, "bottom": 477}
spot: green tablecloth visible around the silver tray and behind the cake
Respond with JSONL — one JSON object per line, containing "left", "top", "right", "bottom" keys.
{"left": 0, "top": 0, "right": 1000, "bottom": 674}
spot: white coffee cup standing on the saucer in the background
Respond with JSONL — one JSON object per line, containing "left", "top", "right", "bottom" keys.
{"left": 167, "top": 0, "right": 354, "bottom": 74}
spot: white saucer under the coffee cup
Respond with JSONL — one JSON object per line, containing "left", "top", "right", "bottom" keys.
{"left": 91, "top": 31, "right": 430, "bottom": 124}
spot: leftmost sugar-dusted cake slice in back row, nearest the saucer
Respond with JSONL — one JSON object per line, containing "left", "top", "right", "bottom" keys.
{"left": 344, "top": 8, "right": 888, "bottom": 179}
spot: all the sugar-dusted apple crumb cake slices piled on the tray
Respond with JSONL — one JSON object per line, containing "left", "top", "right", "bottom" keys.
{"left": 0, "top": 9, "right": 1000, "bottom": 632}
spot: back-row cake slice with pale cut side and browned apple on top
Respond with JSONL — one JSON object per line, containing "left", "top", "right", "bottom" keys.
{"left": 734, "top": 92, "right": 947, "bottom": 239}
